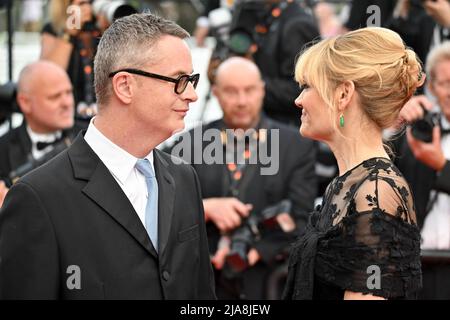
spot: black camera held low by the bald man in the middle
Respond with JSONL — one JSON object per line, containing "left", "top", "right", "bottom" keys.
{"left": 224, "top": 199, "right": 295, "bottom": 278}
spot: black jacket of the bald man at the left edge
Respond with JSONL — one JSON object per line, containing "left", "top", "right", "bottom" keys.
{"left": 0, "top": 120, "right": 85, "bottom": 185}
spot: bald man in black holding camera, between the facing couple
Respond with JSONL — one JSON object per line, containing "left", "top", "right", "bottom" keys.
{"left": 171, "top": 57, "right": 317, "bottom": 299}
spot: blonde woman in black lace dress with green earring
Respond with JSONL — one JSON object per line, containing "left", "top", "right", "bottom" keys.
{"left": 284, "top": 28, "right": 424, "bottom": 299}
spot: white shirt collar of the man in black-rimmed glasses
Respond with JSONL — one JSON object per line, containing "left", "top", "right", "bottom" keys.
{"left": 84, "top": 117, "right": 153, "bottom": 184}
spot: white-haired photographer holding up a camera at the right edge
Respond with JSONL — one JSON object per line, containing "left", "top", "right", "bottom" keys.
{"left": 395, "top": 42, "right": 450, "bottom": 249}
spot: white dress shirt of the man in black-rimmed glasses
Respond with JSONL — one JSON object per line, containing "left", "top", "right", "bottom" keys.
{"left": 84, "top": 118, "right": 154, "bottom": 226}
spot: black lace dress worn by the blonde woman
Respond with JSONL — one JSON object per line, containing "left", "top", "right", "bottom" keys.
{"left": 284, "top": 158, "right": 422, "bottom": 299}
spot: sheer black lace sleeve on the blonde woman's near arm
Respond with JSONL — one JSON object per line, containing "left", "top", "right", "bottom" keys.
{"left": 321, "top": 177, "right": 421, "bottom": 298}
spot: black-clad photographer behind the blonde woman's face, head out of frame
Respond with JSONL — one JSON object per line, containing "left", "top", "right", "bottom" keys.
{"left": 236, "top": 0, "right": 320, "bottom": 126}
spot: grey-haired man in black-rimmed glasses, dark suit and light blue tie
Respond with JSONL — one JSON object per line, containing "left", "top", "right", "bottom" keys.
{"left": 0, "top": 14, "right": 215, "bottom": 299}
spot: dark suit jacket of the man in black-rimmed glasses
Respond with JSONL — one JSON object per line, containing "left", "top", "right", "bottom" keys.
{"left": 0, "top": 134, "right": 215, "bottom": 299}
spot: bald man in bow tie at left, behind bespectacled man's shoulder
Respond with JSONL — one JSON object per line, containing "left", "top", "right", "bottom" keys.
{"left": 0, "top": 61, "right": 80, "bottom": 207}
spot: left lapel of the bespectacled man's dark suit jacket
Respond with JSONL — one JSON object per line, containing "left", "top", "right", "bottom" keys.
{"left": 68, "top": 132, "right": 157, "bottom": 257}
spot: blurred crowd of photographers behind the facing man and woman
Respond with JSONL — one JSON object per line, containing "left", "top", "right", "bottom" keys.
{"left": 0, "top": 0, "right": 450, "bottom": 299}
